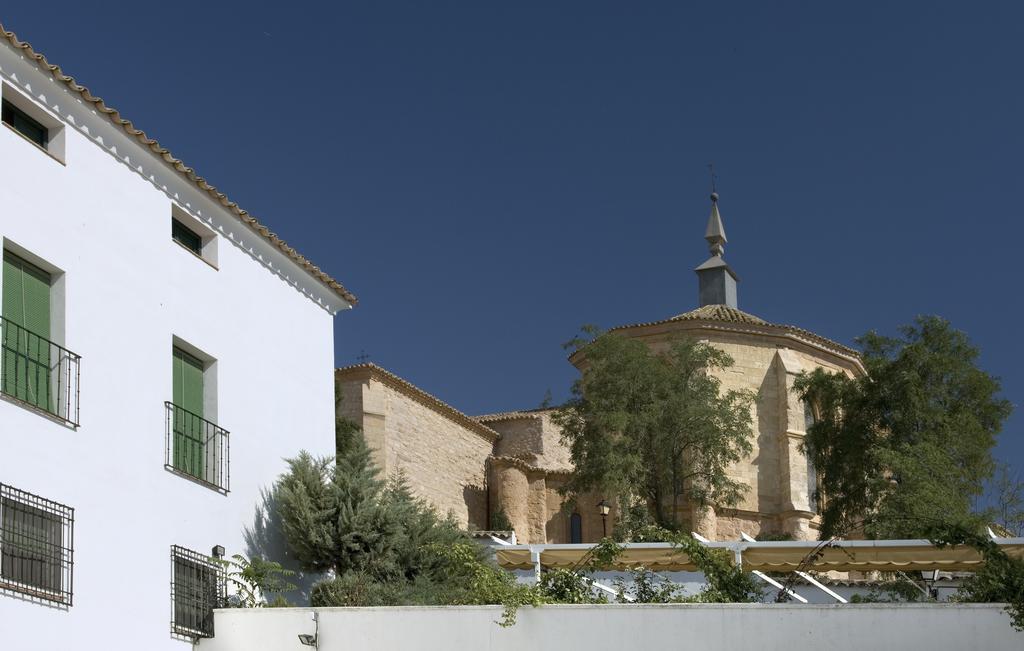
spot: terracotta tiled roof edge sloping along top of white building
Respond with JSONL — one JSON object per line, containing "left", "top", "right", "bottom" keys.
{"left": 0, "top": 23, "right": 358, "bottom": 305}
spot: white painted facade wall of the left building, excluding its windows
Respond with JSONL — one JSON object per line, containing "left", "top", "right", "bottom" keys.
{"left": 0, "top": 36, "right": 347, "bottom": 650}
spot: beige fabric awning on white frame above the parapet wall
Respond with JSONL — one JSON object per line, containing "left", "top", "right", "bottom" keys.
{"left": 496, "top": 538, "right": 1024, "bottom": 572}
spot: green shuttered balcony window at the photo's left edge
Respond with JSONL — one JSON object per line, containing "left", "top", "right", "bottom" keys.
{"left": 0, "top": 251, "right": 54, "bottom": 413}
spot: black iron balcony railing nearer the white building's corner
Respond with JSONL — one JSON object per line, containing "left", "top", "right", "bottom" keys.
{"left": 164, "top": 402, "right": 231, "bottom": 493}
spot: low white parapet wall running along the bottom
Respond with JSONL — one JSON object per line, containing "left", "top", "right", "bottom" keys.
{"left": 197, "top": 604, "right": 1024, "bottom": 651}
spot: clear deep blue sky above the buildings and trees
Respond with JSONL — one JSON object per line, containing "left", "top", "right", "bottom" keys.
{"left": 0, "top": 0, "right": 1024, "bottom": 473}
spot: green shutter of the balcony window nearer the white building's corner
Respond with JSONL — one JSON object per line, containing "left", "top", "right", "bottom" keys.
{"left": 172, "top": 348, "right": 206, "bottom": 479}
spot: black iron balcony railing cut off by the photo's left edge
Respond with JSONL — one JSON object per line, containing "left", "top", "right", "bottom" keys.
{"left": 0, "top": 317, "right": 82, "bottom": 427}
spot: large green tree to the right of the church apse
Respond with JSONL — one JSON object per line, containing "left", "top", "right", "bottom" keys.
{"left": 796, "top": 316, "right": 1011, "bottom": 539}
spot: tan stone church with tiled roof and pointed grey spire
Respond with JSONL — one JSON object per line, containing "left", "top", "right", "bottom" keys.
{"left": 335, "top": 193, "right": 864, "bottom": 544}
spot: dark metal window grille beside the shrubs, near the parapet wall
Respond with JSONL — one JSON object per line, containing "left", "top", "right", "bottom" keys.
{"left": 171, "top": 545, "right": 225, "bottom": 638}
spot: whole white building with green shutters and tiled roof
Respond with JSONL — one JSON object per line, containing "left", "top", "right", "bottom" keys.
{"left": 0, "top": 22, "right": 355, "bottom": 650}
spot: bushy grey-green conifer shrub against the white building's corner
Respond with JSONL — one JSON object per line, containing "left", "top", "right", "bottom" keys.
{"left": 274, "top": 434, "right": 482, "bottom": 606}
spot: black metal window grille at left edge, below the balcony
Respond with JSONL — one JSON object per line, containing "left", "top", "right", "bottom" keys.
{"left": 0, "top": 484, "right": 75, "bottom": 606}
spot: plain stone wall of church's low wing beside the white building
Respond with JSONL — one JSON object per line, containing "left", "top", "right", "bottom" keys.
{"left": 338, "top": 370, "right": 494, "bottom": 529}
